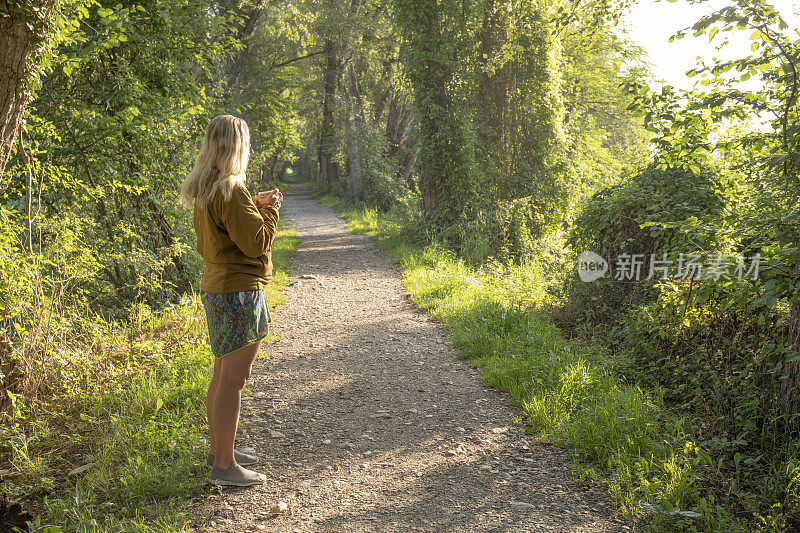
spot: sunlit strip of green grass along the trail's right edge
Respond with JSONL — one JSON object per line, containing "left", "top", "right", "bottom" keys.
{"left": 321, "top": 197, "right": 752, "bottom": 531}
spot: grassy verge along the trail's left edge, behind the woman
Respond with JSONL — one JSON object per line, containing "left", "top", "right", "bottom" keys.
{"left": 0, "top": 218, "right": 299, "bottom": 533}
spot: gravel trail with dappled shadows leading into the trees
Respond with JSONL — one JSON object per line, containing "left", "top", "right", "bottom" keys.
{"left": 196, "top": 185, "right": 628, "bottom": 533}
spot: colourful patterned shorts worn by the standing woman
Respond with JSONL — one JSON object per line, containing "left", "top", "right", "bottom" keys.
{"left": 200, "top": 290, "right": 270, "bottom": 357}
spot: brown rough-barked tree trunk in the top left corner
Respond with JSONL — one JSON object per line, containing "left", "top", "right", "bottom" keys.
{"left": 0, "top": 0, "right": 54, "bottom": 175}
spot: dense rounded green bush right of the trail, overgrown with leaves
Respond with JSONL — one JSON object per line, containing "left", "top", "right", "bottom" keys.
{"left": 553, "top": 166, "right": 732, "bottom": 330}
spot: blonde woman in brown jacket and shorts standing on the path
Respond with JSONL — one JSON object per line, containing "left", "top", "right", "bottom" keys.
{"left": 181, "top": 115, "right": 282, "bottom": 487}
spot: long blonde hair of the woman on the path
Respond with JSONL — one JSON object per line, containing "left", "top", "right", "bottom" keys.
{"left": 181, "top": 115, "right": 250, "bottom": 206}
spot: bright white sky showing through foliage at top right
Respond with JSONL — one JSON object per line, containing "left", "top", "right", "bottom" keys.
{"left": 623, "top": 0, "right": 800, "bottom": 89}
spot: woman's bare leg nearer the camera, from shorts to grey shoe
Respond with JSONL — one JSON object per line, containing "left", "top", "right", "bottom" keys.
{"left": 211, "top": 341, "right": 261, "bottom": 470}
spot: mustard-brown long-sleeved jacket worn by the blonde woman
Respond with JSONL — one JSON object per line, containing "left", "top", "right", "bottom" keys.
{"left": 194, "top": 185, "right": 278, "bottom": 294}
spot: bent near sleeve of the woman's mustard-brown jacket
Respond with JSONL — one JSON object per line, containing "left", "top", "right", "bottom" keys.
{"left": 221, "top": 187, "right": 279, "bottom": 257}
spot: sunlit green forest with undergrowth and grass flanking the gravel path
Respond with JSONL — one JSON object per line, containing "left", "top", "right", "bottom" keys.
{"left": 0, "top": 0, "right": 800, "bottom": 532}
